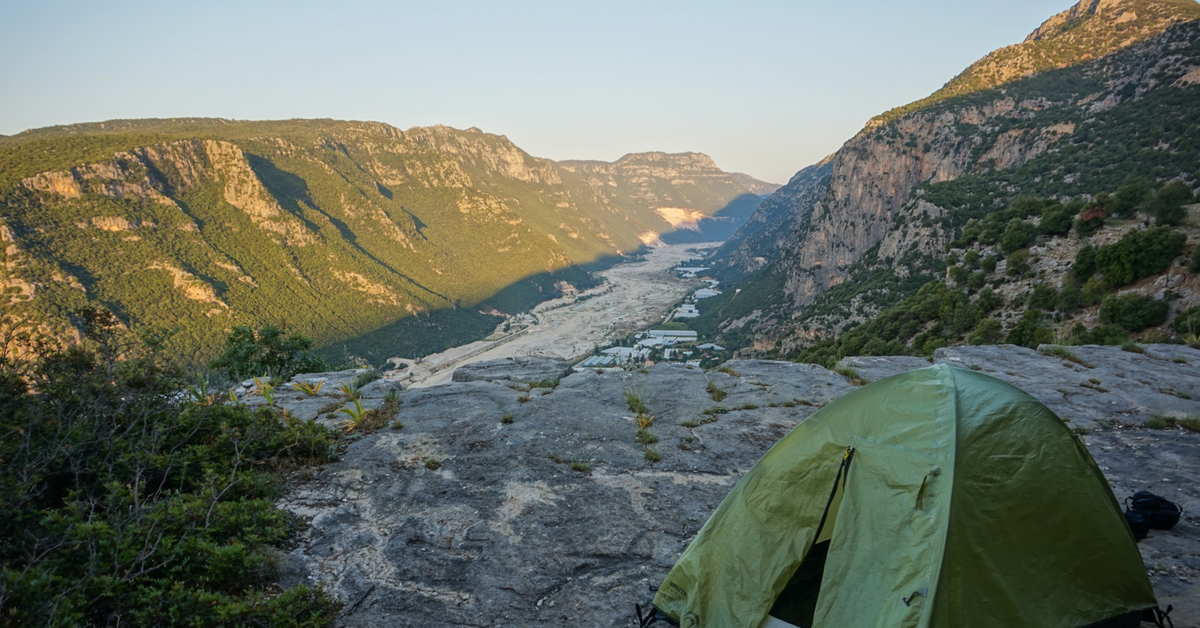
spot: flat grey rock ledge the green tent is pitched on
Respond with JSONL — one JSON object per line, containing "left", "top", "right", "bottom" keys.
{"left": 267, "top": 345, "right": 1200, "bottom": 627}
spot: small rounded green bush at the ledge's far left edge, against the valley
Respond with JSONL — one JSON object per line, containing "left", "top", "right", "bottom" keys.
{"left": 210, "top": 325, "right": 330, "bottom": 379}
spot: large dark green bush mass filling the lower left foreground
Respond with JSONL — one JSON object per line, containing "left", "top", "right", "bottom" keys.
{"left": 0, "top": 318, "right": 338, "bottom": 628}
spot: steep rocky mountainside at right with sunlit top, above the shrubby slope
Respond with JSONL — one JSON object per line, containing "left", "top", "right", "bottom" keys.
{"left": 714, "top": 0, "right": 1200, "bottom": 346}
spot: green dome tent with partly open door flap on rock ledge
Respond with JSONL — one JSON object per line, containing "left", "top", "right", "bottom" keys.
{"left": 654, "top": 365, "right": 1156, "bottom": 628}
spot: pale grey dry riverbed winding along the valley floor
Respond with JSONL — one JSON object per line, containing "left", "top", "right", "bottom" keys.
{"left": 388, "top": 243, "right": 720, "bottom": 388}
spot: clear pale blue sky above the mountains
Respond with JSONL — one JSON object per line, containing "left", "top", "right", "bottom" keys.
{"left": 0, "top": 0, "right": 1072, "bottom": 183}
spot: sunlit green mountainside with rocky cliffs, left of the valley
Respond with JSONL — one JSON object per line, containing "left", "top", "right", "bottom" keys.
{"left": 0, "top": 120, "right": 768, "bottom": 360}
